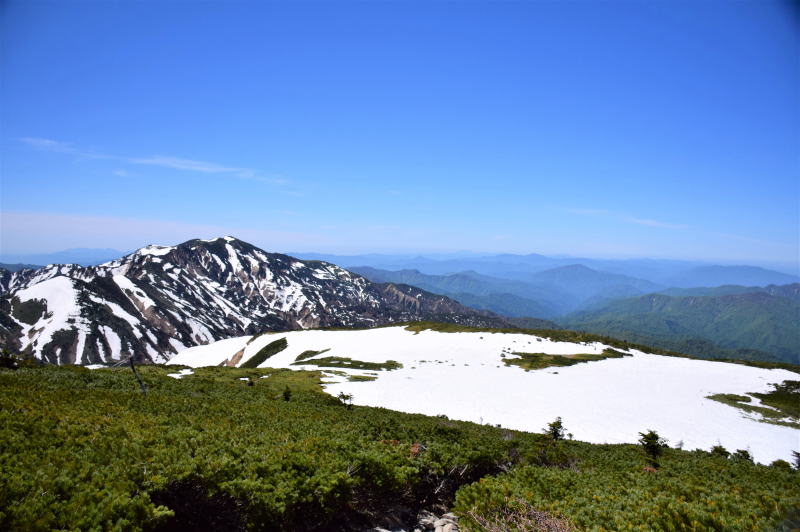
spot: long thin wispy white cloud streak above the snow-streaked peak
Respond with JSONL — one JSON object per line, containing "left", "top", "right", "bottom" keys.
{"left": 19, "top": 137, "right": 289, "bottom": 185}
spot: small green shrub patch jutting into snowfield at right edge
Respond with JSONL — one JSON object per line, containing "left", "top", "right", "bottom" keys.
{"left": 708, "top": 381, "right": 800, "bottom": 429}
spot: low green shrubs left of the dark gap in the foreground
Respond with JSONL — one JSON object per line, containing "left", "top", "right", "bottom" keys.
{"left": 0, "top": 366, "right": 506, "bottom": 531}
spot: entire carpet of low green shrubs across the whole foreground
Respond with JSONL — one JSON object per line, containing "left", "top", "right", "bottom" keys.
{"left": 0, "top": 366, "right": 800, "bottom": 532}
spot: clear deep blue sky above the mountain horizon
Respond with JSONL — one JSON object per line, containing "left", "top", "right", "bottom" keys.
{"left": 0, "top": 0, "right": 800, "bottom": 263}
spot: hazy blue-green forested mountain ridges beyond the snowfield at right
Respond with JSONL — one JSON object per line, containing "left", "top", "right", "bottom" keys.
{"left": 350, "top": 265, "right": 800, "bottom": 363}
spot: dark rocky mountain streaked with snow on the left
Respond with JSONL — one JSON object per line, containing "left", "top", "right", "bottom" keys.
{"left": 0, "top": 237, "right": 508, "bottom": 364}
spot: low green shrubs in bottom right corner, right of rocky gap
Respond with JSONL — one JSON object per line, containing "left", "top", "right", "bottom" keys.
{"left": 455, "top": 431, "right": 800, "bottom": 532}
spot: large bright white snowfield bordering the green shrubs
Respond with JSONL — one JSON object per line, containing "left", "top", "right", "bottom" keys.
{"left": 169, "top": 327, "right": 800, "bottom": 463}
